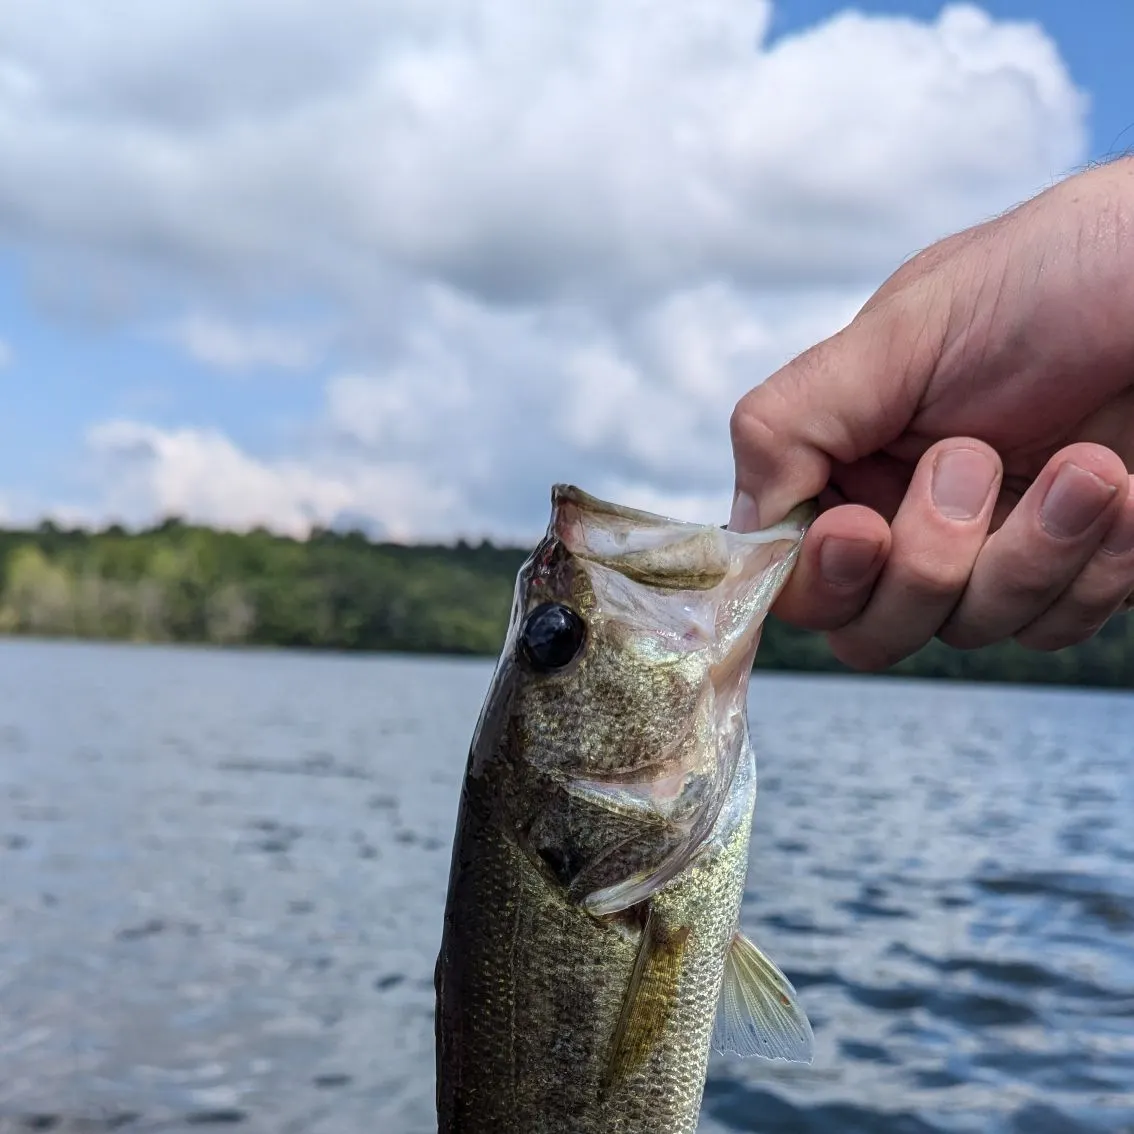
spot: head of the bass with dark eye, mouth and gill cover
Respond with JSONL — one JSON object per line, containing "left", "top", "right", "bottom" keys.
{"left": 483, "top": 485, "right": 809, "bottom": 914}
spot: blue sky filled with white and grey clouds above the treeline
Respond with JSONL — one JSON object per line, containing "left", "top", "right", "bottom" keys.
{"left": 0, "top": 0, "right": 1134, "bottom": 542}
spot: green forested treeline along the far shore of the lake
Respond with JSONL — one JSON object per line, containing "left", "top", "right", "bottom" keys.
{"left": 0, "top": 519, "right": 1134, "bottom": 687}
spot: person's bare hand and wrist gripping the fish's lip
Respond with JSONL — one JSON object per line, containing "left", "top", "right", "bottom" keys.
{"left": 731, "top": 158, "right": 1134, "bottom": 669}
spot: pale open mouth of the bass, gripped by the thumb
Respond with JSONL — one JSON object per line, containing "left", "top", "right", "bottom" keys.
{"left": 548, "top": 484, "right": 818, "bottom": 591}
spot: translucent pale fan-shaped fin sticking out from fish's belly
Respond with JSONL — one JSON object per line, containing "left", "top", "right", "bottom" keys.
{"left": 712, "top": 932, "right": 815, "bottom": 1064}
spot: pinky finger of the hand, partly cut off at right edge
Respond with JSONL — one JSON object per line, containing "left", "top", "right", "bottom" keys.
{"left": 1016, "top": 484, "right": 1134, "bottom": 650}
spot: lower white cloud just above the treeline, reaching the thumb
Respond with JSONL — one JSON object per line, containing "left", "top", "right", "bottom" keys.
{"left": 75, "top": 278, "right": 898, "bottom": 541}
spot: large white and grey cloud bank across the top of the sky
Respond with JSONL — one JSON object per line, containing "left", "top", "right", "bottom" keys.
{"left": 0, "top": 0, "right": 1084, "bottom": 299}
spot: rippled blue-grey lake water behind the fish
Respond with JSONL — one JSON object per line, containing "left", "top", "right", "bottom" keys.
{"left": 0, "top": 642, "right": 1134, "bottom": 1134}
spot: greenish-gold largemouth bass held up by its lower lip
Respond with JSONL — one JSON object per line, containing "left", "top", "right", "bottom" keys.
{"left": 434, "top": 484, "right": 813, "bottom": 1134}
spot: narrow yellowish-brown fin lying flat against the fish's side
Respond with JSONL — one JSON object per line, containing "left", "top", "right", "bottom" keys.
{"left": 603, "top": 911, "right": 689, "bottom": 1091}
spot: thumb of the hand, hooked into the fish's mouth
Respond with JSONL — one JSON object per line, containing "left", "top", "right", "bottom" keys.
{"left": 729, "top": 297, "right": 945, "bottom": 532}
